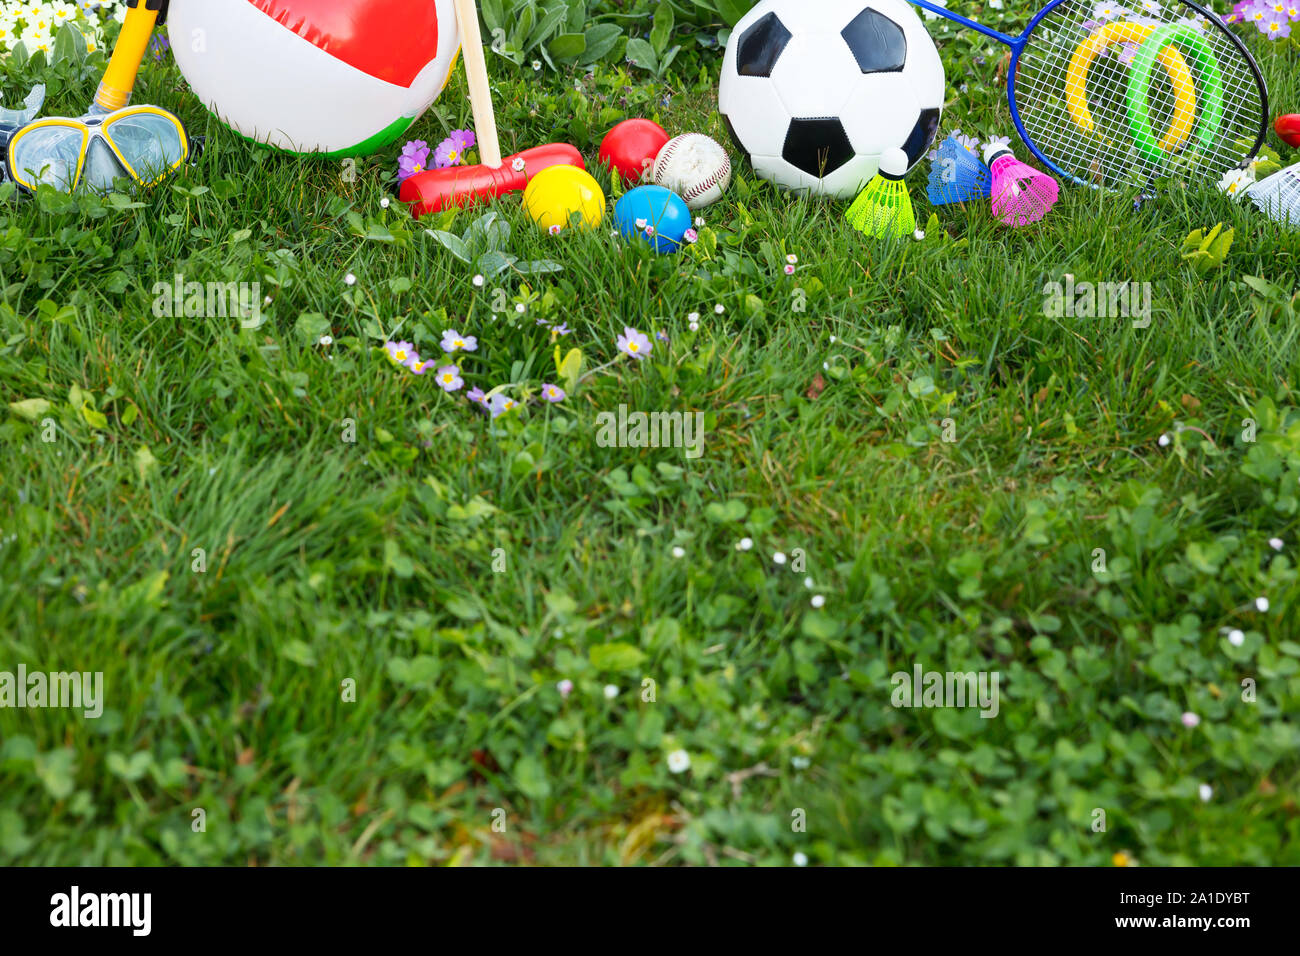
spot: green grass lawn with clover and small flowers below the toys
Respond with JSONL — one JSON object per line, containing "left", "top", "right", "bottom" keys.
{"left": 0, "top": 5, "right": 1300, "bottom": 865}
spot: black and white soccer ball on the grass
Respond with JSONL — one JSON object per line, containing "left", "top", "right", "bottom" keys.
{"left": 718, "top": 0, "right": 944, "bottom": 199}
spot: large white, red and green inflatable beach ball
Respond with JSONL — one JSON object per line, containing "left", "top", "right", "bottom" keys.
{"left": 168, "top": 0, "right": 460, "bottom": 157}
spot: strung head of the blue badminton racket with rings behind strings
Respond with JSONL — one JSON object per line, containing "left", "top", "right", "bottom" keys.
{"left": 1015, "top": 0, "right": 1265, "bottom": 189}
